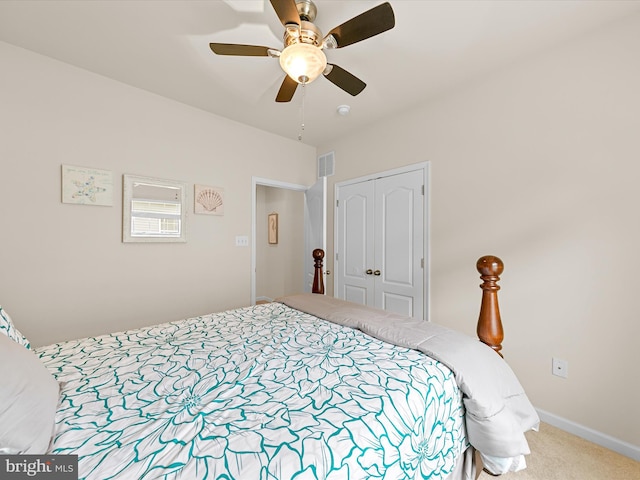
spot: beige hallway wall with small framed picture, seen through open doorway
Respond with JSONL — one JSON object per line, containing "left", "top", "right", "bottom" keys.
{"left": 256, "top": 185, "right": 305, "bottom": 300}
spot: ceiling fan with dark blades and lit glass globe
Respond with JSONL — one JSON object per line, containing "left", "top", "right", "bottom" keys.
{"left": 209, "top": 0, "right": 395, "bottom": 102}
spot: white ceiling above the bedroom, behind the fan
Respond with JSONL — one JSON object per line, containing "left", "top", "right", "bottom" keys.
{"left": 0, "top": 0, "right": 640, "bottom": 145}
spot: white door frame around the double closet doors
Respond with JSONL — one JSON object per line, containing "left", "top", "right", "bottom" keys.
{"left": 333, "top": 161, "right": 431, "bottom": 321}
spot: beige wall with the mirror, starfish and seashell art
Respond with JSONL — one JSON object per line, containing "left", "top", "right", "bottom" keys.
{"left": 0, "top": 42, "right": 315, "bottom": 345}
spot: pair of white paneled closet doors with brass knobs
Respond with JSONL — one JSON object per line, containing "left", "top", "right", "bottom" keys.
{"left": 336, "top": 170, "right": 425, "bottom": 318}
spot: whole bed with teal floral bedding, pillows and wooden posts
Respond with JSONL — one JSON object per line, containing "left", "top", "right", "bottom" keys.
{"left": 0, "top": 250, "right": 539, "bottom": 480}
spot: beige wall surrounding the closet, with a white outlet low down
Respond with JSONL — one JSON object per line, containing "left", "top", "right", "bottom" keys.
{"left": 318, "top": 15, "right": 640, "bottom": 451}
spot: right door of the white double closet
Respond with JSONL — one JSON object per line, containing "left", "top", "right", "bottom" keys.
{"left": 374, "top": 171, "right": 424, "bottom": 318}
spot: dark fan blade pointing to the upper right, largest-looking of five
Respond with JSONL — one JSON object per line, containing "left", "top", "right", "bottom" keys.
{"left": 325, "top": 2, "right": 396, "bottom": 48}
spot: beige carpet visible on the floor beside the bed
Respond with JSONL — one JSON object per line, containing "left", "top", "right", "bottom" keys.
{"left": 479, "top": 423, "right": 640, "bottom": 480}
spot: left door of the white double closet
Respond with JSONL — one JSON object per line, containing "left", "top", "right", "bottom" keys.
{"left": 335, "top": 181, "right": 375, "bottom": 306}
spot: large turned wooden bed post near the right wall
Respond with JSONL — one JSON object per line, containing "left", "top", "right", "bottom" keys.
{"left": 476, "top": 255, "right": 504, "bottom": 357}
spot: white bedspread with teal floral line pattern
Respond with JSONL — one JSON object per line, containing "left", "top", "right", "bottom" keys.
{"left": 37, "top": 303, "right": 468, "bottom": 480}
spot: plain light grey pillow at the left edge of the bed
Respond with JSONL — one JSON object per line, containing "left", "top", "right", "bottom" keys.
{"left": 0, "top": 335, "right": 60, "bottom": 455}
